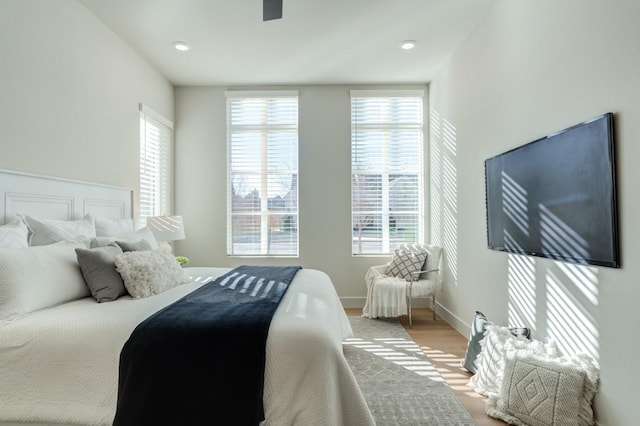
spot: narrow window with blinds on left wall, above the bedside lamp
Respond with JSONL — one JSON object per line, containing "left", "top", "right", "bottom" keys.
{"left": 140, "top": 104, "right": 173, "bottom": 226}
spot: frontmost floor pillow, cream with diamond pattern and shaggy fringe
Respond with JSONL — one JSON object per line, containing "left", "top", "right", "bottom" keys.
{"left": 486, "top": 342, "right": 599, "bottom": 426}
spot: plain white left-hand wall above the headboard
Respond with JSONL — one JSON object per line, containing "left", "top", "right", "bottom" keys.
{"left": 0, "top": 0, "right": 173, "bottom": 210}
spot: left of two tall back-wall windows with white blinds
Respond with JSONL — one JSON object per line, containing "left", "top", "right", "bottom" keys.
{"left": 226, "top": 91, "right": 298, "bottom": 256}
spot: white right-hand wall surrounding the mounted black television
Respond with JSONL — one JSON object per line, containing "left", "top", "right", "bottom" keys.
{"left": 430, "top": 0, "right": 640, "bottom": 426}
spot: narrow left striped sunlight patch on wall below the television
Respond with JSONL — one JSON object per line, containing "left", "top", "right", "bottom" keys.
{"left": 507, "top": 254, "right": 536, "bottom": 330}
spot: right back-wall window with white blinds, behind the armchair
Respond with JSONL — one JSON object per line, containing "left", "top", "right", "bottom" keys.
{"left": 351, "top": 90, "right": 424, "bottom": 255}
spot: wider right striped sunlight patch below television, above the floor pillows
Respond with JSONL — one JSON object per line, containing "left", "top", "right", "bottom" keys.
{"left": 546, "top": 271, "right": 600, "bottom": 362}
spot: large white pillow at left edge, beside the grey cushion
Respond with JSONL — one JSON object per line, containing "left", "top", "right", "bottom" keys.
{"left": 0, "top": 242, "right": 90, "bottom": 321}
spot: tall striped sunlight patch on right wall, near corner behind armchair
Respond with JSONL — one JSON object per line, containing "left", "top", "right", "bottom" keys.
{"left": 429, "top": 109, "right": 458, "bottom": 285}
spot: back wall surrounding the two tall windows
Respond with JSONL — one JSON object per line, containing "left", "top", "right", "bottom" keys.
{"left": 175, "top": 85, "right": 427, "bottom": 307}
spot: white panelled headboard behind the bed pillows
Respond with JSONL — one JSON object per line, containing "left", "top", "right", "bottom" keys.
{"left": 0, "top": 169, "right": 133, "bottom": 224}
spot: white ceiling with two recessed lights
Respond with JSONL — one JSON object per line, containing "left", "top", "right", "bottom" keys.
{"left": 79, "top": 0, "right": 497, "bottom": 86}
